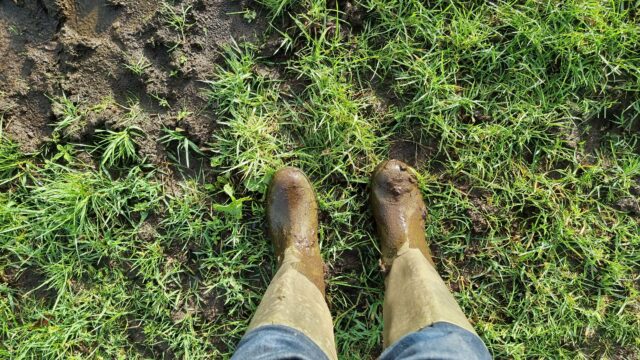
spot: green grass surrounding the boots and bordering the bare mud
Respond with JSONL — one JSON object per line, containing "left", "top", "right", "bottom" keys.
{"left": 0, "top": 0, "right": 640, "bottom": 359}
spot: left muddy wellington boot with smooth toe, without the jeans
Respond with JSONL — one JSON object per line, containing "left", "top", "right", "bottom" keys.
{"left": 248, "top": 168, "right": 337, "bottom": 359}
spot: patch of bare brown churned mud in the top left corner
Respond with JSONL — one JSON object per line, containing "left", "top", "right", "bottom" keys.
{"left": 0, "top": 0, "right": 266, "bottom": 164}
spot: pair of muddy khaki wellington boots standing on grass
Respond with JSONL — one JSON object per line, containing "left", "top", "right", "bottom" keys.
{"left": 249, "top": 160, "right": 474, "bottom": 359}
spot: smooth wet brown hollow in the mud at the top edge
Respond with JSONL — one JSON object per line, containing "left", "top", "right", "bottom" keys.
{"left": 62, "top": 0, "right": 119, "bottom": 36}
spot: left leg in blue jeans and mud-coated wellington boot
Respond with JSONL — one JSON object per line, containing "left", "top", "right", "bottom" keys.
{"left": 234, "top": 168, "right": 337, "bottom": 359}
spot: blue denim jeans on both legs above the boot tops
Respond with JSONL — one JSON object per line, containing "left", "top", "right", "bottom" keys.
{"left": 231, "top": 322, "right": 491, "bottom": 360}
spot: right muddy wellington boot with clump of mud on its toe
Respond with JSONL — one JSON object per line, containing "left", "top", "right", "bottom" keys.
{"left": 371, "top": 160, "right": 475, "bottom": 348}
